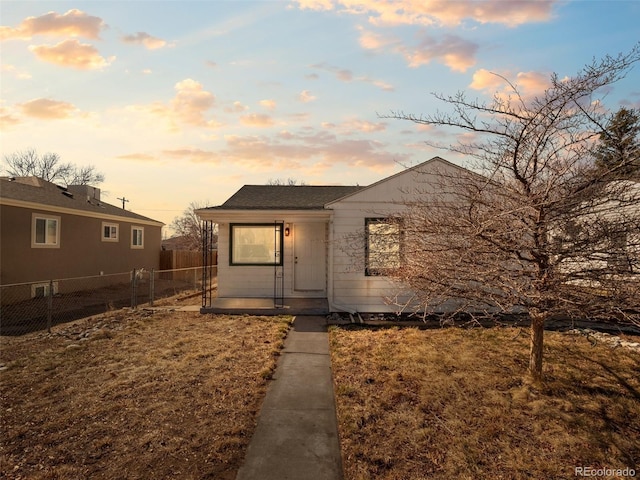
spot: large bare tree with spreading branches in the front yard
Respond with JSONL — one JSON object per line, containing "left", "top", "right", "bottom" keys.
{"left": 386, "top": 44, "right": 640, "bottom": 380}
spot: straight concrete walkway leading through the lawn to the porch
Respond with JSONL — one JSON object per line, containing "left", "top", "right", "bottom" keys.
{"left": 236, "top": 316, "right": 342, "bottom": 480}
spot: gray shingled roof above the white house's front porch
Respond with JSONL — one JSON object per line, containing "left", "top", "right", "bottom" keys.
{"left": 210, "top": 185, "right": 363, "bottom": 210}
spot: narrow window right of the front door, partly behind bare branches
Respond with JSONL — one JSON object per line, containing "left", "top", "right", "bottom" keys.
{"left": 365, "top": 218, "right": 401, "bottom": 275}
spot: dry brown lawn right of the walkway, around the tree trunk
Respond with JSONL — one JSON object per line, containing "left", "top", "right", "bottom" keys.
{"left": 330, "top": 327, "right": 640, "bottom": 480}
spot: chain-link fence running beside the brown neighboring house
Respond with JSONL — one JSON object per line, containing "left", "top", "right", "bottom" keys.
{"left": 0, "top": 266, "right": 216, "bottom": 335}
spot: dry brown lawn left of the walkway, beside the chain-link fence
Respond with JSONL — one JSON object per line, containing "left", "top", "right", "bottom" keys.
{"left": 0, "top": 311, "right": 291, "bottom": 480}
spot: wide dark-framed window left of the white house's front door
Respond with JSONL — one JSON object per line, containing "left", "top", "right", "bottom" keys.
{"left": 229, "top": 223, "right": 282, "bottom": 265}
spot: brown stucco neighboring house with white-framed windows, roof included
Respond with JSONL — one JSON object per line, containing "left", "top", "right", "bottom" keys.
{"left": 0, "top": 177, "right": 163, "bottom": 294}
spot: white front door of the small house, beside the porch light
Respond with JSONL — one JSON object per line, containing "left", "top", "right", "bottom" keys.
{"left": 293, "top": 223, "right": 327, "bottom": 292}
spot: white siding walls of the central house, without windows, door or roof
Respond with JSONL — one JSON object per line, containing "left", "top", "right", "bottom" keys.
{"left": 201, "top": 157, "right": 472, "bottom": 313}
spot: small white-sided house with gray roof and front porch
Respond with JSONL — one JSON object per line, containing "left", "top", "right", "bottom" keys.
{"left": 197, "top": 157, "right": 464, "bottom": 313}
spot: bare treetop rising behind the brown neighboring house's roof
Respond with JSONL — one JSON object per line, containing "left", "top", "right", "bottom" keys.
{"left": 4, "top": 149, "right": 104, "bottom": 186}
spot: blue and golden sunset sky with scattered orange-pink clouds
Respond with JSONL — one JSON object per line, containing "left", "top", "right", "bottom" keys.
{"left": 0, "top": 0, "right": 640, "bottom": 236}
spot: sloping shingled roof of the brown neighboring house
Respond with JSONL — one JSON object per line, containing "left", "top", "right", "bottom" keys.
{"left": 0, "top": 177, "right": 162, "bottom": 223}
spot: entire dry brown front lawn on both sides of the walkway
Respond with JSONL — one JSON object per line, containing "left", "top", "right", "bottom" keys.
{"left": 0, "top": 310, "right": 640, "bottom": 480}
